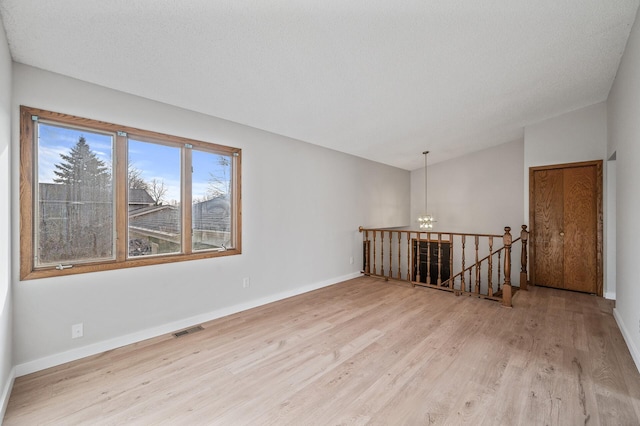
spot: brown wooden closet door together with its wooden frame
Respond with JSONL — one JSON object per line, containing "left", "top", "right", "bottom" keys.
{"left": 529, "top": 161, "right": 602, "bottom": 296}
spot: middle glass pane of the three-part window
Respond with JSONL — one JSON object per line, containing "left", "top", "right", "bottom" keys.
{"left": 127, "top": 139, "right": 182, "bottom": 257}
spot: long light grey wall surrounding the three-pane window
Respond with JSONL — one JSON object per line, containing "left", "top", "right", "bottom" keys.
{"left": 11, "top": 64, "right": 410, "bottom": 375}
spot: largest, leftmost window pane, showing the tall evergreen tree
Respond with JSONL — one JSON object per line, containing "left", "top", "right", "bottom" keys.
{"left": 34, "top": 122, "right": 115, "bottom": 266}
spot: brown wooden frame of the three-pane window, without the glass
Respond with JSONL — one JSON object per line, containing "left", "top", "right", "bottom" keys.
{"left": 20, "top": 106, "right": 242, "bottom": 280}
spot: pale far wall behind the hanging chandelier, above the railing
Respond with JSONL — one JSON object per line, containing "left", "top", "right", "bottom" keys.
{"left": 410, "top": 140, "right": 523, "bottom": 234}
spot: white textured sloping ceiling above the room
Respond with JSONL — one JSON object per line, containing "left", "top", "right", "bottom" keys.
{"left": 0, "top": 0, "right": 639, "bottom": 170}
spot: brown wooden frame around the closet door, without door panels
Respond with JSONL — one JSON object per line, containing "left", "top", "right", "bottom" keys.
{"left": 529, "top": 160, "right": 603, "bottom": 296}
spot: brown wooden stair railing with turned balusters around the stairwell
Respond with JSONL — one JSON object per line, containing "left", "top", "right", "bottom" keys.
{"left": 359, "top": 225, "right": 529, "bottom": 306}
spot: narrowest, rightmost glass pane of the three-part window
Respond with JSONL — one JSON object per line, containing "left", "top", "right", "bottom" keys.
{"left": 191, "top": 149, "right": 233, "bottom": 251}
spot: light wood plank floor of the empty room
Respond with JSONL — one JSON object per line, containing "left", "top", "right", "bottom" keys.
{"left": 5, "top": 278, "right": 640, "bottom": 426}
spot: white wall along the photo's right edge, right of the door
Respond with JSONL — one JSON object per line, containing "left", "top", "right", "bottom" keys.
{"left": 607, "top": 5, "right": 640, "bottom": 369}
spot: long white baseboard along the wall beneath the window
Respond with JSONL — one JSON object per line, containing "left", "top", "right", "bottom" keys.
{"left": 14, "top": 272, "right": 361, "bottom": 377}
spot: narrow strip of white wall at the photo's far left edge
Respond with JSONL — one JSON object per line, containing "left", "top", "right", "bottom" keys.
{"left": 0, "top": 14, "right": 14, "bottom": 419}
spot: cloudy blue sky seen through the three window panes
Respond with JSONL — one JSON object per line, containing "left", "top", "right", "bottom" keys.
{"left": 38, "top": 123, "right": 230, "bottom": 203}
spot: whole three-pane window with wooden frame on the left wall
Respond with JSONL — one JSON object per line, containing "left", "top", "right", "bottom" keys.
{"left": 20, "top": 107, "right": 241, "bottom": 279}
